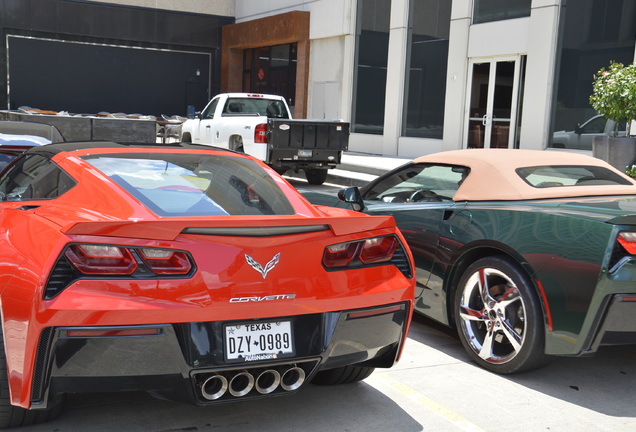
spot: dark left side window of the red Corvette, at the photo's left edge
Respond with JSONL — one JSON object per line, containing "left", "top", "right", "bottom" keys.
{"left": 0, "top": 155, "right": 76, "bottom": 201}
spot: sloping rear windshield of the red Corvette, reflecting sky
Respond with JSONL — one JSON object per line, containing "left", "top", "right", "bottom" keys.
{"left": 84, "top": 153, "right": 294, "bottom": 216}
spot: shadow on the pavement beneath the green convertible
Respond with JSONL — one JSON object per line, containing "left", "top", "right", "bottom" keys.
{"left": 408, "top": 314, "right": 636, "bottom": 418}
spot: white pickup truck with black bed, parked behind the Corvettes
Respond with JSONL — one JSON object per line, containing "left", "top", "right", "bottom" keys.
{"left": 181, "top": 93, "right": 349, "bottom": 184}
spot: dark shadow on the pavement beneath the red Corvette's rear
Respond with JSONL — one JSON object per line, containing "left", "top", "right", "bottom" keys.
{"left": 20, "top": 376, "right": 422, "bottom": 432}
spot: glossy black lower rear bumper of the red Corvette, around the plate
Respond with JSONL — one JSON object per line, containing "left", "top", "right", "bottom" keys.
{"left": 31, "top": 302, "right": 412, "bottom": 408}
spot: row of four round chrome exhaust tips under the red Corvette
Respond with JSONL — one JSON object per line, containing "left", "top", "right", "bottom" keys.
{"left": 199, "top": 366, "right": 306, "bottom": 401}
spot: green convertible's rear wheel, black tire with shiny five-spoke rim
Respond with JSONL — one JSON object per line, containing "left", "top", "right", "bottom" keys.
{"left": 453, "top": 257, "right": 547, "bottom": 374}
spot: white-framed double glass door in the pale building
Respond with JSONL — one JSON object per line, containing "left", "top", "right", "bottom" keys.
{"left": 464, "top": 57, "right": 525, "bottom": 148}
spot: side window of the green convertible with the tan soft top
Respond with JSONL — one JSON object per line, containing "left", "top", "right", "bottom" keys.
{"left": 362, "top": 164, "right": 470, "bottom": 203}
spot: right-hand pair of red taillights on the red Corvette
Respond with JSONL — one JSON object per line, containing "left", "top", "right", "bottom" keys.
{"left": 322, "top": 236, "right": 398, "bottom": 268}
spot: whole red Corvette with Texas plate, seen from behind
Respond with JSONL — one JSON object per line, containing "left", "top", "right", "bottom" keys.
{"left": 0, "top": 142, "right": 415, "bottom": 427}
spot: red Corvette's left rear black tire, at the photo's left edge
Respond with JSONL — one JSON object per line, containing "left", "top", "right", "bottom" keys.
{"left": 0, "top": 330, "right": 62, "bottom": 429}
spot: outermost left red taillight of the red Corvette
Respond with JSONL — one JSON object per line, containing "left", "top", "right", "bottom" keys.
{"left": 65, "top": 244, "right": 137, "bottom": 275}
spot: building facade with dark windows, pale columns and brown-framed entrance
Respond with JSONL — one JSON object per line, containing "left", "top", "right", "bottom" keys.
{"left": 0, "top": 0, "right": 636, "bottom": 157}
